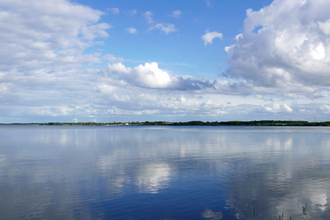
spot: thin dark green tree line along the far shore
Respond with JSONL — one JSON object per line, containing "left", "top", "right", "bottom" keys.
{"left": 2, "top": 120, "right": 330, "bottom": 126}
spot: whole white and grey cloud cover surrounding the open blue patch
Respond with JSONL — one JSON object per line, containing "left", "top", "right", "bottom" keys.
{"left": 0, "top": 0, "right": 330, "bottom": 122}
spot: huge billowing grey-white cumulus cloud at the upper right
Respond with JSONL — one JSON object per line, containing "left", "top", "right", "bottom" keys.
{"left": 222, "top": 0, "right": 330, "bottom": 97}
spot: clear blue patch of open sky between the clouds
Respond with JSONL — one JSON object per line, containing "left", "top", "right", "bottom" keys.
{"left": 79, "top": 0, "right": 271, "bottom": 77}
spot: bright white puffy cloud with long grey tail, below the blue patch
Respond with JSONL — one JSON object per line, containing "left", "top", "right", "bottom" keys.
{"left": 107, "top": 62, "right": 284, "bottom": 96}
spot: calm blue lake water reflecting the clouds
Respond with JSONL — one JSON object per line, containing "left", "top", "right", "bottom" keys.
{"left": 0, "top": 126, "right": 330, "bottom": 220}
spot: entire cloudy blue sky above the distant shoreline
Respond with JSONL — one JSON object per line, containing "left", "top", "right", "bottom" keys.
{"left": 0, "top": 0, "right": 330, "bottom": 123}
